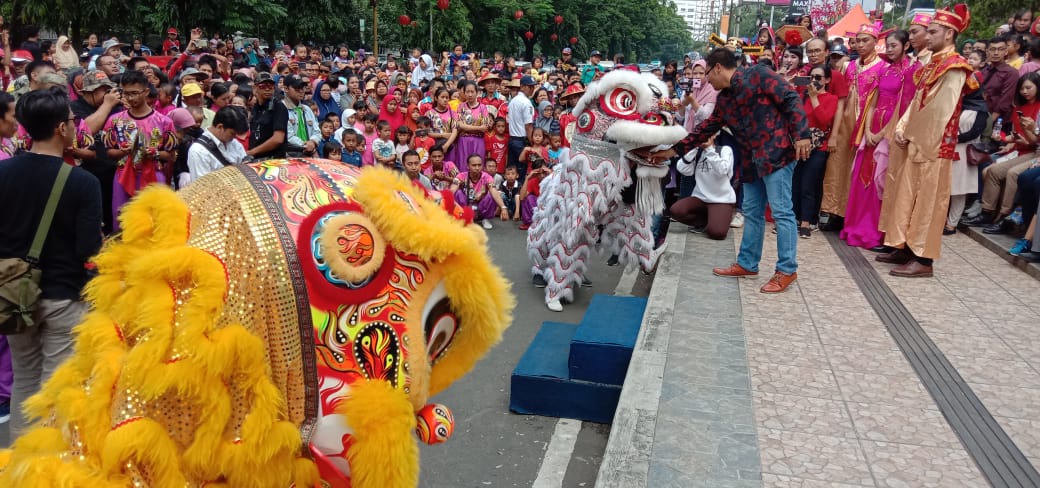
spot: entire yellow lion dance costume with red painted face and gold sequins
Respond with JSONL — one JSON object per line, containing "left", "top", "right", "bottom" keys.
{"left": 0, "top": 160, "right": 514, "bottom": 488}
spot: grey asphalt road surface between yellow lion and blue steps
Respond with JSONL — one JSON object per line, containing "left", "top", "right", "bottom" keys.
{"left": 0, "top": 221, "right": 649, "bottom": 488}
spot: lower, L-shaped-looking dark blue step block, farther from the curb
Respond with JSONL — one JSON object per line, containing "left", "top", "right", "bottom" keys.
{"left": 510, "top": 322, "right": 621, "bottom": 423}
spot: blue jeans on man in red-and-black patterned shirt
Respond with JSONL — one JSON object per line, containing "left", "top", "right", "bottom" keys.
{"left": 736, "top": 163, "right": 798, "bottom": 275}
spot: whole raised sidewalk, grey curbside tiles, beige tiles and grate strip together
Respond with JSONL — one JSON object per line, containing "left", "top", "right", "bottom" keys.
{"left": 597, "top": 225, "right": 1040, "bottom": 488}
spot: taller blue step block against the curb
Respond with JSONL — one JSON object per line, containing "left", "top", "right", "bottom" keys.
{"left": 569, "top": 294, "right": 647, "bottom": 385}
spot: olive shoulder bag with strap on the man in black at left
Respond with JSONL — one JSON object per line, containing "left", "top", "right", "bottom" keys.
{"left": 0, "top": 163, "right": 72, "bottom": 335}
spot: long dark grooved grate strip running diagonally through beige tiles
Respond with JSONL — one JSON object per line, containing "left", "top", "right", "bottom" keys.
{"left": 826, "top": 232, "right": 1040, "bottom": 487}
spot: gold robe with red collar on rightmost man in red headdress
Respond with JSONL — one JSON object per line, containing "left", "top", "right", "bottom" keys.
{"left": 878, "top": 50, "right": 970, "bottom": 259}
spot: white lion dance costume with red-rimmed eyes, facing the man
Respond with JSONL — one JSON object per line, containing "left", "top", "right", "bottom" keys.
{"left": 527, "top": 70, "right": 686, "bottom": 311}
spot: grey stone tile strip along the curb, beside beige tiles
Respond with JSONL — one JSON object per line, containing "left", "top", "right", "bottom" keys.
{"left": 596, "top": 226, "right": 761, "bottom": 488}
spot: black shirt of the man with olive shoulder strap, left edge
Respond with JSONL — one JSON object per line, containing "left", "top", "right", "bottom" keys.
{"left": 0, "top": 153, "right": 101, "bottom": 300}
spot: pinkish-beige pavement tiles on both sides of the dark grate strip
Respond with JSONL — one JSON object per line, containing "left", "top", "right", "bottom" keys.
{"left": 740, "top": 227, "right": 1040, "bottom": 487}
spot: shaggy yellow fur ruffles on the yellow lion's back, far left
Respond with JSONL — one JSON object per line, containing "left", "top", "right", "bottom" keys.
{"left": 0, "top": 186, "right": 317, "bottom": 482}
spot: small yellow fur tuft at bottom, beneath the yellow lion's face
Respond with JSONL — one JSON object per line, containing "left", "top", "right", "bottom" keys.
{"left": 336, "top": 381, "right": 419, "bottom": 488}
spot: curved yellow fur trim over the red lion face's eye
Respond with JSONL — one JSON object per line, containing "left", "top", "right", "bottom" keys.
{"left": 353, "top": 166, "right": 516, "bottom": 395}
